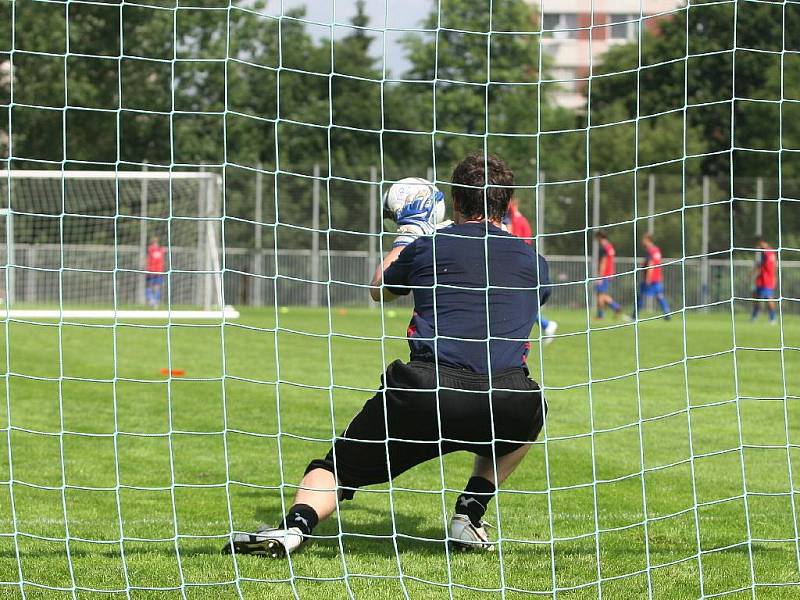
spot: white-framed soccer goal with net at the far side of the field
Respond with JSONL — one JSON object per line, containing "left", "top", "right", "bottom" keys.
{"left": 0, "top": 170, "right": 238, "bottom": 319}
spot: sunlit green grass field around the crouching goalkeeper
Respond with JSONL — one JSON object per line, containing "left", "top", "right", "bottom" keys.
{"left": 0, "top": 307, "right": 800, "bottom": 600}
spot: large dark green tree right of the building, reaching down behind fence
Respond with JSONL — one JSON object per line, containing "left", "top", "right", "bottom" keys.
{"left": 588, "top": 2, "right": 800, "bottom": 253}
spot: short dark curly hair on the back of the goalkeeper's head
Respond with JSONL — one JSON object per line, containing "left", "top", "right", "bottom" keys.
{"left": 453, "top": 152, "right": 514, "bottom": 221}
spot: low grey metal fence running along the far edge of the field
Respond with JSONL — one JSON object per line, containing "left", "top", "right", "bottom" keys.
{"left": 2, "top": 244, "right": 800, "bottom": 312}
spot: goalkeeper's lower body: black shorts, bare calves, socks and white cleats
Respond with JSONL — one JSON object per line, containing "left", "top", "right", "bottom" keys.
{"left": 225, "top": 361, "right": 546, "bottom": 557}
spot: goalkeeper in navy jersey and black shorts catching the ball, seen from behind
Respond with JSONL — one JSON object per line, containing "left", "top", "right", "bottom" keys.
{"left": 223, "top": 154, "right": 548, "bottom": 557}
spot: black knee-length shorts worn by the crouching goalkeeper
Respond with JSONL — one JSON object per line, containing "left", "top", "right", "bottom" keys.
{"left": 309, "top": 360, "right": 547, "bottom": 498}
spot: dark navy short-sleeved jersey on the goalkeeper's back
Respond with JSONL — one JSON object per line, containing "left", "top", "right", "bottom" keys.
{"left": 383, "top": 222, "right": 549, "bottom": 374}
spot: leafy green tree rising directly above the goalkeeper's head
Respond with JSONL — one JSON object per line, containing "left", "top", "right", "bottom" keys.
{"left": 396, "top": 0, "right": 587, "bottom": 251}
